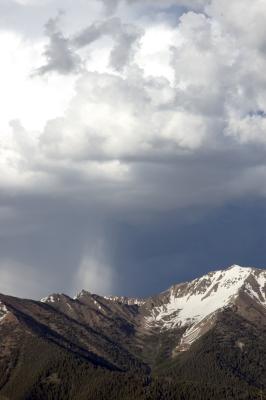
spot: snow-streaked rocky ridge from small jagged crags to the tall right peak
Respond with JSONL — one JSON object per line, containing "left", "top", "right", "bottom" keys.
{"left": 37, "top": 264, "right": 266, "bottom": 350}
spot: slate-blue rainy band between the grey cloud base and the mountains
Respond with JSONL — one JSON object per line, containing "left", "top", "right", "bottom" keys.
{"left": 0, "top": 177, "right": 266, "bottom": 298}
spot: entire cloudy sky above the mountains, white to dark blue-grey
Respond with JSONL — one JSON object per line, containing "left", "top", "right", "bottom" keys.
{"left": 0, "top": 0, "right": 266, "bottom": 299}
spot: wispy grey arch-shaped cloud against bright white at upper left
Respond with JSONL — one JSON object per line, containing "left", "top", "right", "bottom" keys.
{"left": 36, "top": 13, "right": 143, "bottom": 75}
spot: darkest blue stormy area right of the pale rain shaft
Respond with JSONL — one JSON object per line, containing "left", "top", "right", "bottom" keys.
{"left": 109, "top": 200, "right": 266, "bottom": 296}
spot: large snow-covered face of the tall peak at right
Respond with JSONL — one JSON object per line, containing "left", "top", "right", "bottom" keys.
{"left": 146, "top": 265, "right": 266, "bottom": 349}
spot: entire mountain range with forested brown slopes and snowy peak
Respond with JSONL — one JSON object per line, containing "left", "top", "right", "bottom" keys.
{"left": 0, "top": 265, "right": 266, "bottom": 400}
